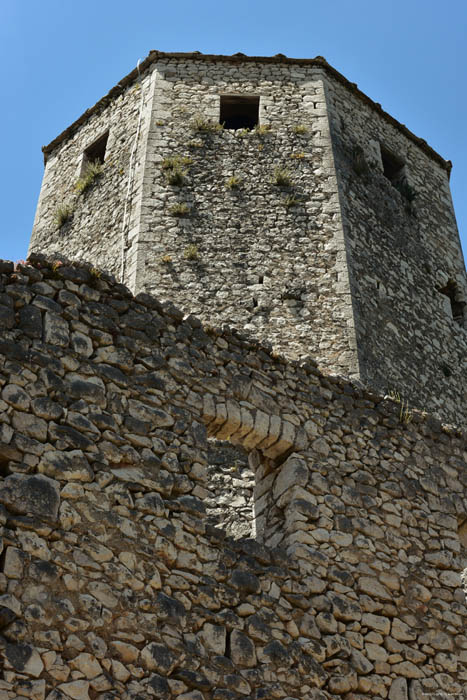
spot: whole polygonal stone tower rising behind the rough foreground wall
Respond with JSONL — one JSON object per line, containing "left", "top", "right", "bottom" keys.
{"left": 30, "top": 51, "right": 467, "bottom": 424}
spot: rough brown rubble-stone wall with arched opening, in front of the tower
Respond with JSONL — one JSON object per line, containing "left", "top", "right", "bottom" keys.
{"left": 0, "top": 258, "right": 467, "bottom": 700}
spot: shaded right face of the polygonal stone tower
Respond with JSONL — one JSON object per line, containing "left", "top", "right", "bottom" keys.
{"left": 326, "top": 71, "right": 467, "bottom": 425}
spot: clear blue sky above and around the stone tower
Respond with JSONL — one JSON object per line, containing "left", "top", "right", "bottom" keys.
{"left": 0, "top": 0, "right": 467, "bottom": 260}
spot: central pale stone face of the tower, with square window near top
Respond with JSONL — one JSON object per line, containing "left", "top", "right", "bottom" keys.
{"left": 131, "top": 59, "right": 357, "bottom": 375}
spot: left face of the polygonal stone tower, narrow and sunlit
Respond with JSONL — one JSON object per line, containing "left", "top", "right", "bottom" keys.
{"left": 29, "top": 67, "right": 153, "bottom": 277}
